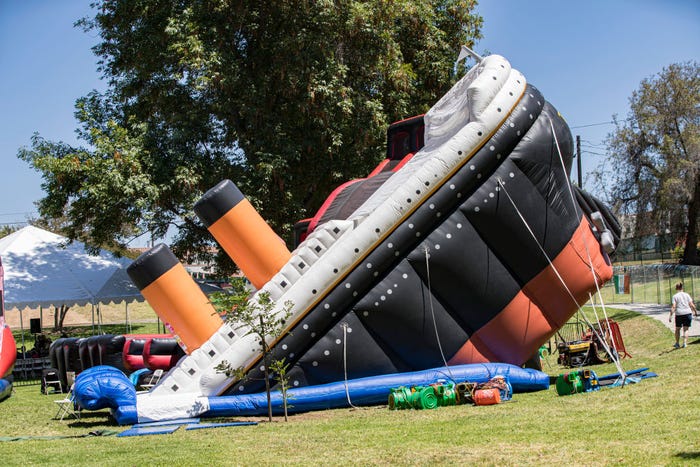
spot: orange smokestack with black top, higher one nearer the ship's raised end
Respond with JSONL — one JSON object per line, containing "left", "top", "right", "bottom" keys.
{"left": 194, "top": 180, "right": 291, "bottom": 289}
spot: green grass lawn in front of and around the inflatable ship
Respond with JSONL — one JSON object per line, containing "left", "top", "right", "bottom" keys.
{"left": 0, "top": 309, "right": 700, "bottom": 466}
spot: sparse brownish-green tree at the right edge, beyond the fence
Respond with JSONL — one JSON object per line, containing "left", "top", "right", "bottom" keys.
{"left": 599, "top": 62, "right": 700, "bottom": 264}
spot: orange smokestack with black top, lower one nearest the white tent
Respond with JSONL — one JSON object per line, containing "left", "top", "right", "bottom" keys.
{"left": 126, "top": 247, "right": 223, "bottom": 354}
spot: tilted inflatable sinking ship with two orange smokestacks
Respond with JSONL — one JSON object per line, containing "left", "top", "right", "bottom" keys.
{"left": 76, "top": 50, "right": 620, "bottom": 421}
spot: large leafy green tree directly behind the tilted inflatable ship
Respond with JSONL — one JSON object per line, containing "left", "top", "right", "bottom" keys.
{"left": 19, "top": 0, "right": 481, "bottom": 272}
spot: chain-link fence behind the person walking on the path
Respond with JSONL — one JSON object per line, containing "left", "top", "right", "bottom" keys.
{"left": 593, "top": 264, "right": 700, "bottom": 305}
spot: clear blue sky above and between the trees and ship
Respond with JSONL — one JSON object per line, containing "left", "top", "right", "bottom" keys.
{"left": 0, "top": 0, "right": 700, "bottom": 245}
